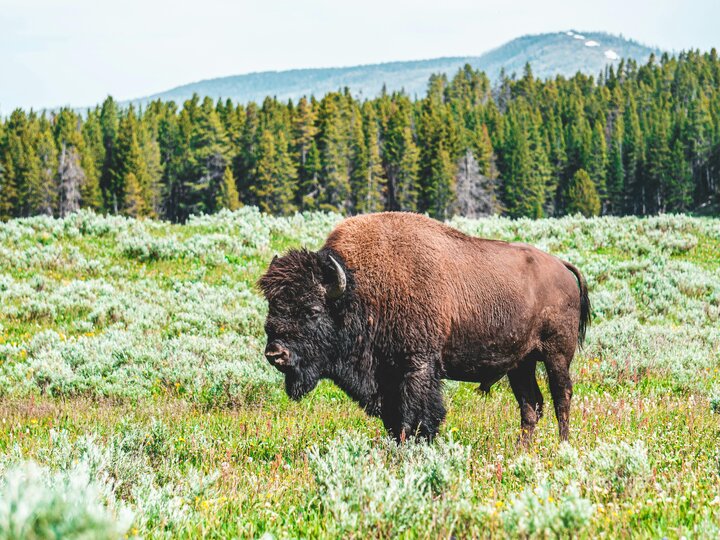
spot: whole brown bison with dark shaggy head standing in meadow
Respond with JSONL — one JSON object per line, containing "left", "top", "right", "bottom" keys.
{"left": 258, "top": 212, "right": 590, "bottom": 445}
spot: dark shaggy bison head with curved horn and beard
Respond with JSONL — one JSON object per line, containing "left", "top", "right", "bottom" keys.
{"left": 258, "top": 250, "right": 348, "bottom": 400}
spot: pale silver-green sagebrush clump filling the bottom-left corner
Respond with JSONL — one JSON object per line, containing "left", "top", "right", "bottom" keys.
{"left": 0, "top": 428, "right": 218, "bottom": 538}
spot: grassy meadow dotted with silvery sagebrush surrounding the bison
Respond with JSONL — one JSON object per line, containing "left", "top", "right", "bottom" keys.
{"left": 0, "top": 208, "right": 720, "bottom": 538}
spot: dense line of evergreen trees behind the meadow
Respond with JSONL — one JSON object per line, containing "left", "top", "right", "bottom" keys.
{"left": 0, "top": 49, "right": 720, "bottom": 221}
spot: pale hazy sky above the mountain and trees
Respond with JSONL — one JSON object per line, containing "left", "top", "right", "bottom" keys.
{"left": 0, "top": 0, "right": 720, "bottom": 115}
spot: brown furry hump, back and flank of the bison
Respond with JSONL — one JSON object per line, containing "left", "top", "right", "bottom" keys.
{"left": 325, "top": 212, "right": 579, "bottom": 365}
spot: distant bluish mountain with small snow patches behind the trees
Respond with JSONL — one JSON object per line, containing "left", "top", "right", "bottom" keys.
{"left": 131, "top": 31, "right": 661, "bottom": 104}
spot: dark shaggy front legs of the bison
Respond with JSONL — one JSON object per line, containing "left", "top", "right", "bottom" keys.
{"left": 383, "top": 362, "right": 445, "bottom": 442}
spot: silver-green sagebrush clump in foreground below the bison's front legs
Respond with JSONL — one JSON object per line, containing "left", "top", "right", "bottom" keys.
{"left": 308, "top": 433, "right": 481, "bottom": 536}
